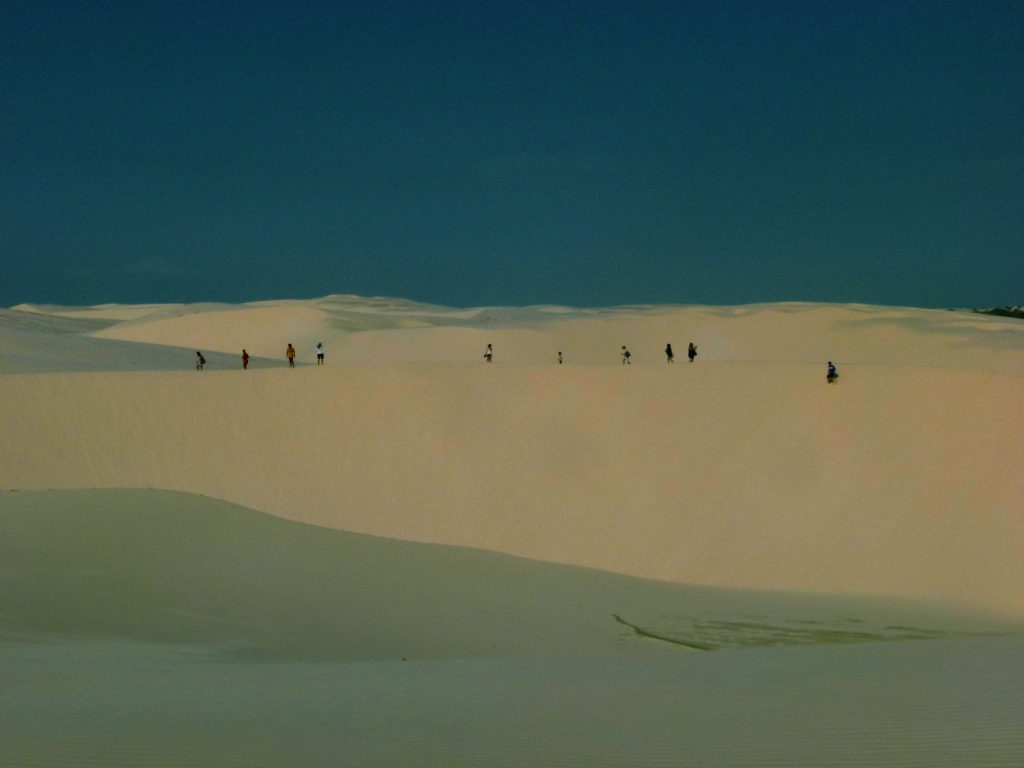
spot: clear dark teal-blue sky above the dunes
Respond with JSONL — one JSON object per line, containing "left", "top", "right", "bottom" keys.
{"left": 0, "top": 0, "right": 1024, "bottom": 307}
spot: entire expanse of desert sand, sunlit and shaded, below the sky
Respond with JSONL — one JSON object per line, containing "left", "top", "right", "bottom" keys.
{"left": 0, "top": 296, "right": 1024, "bottom": 766}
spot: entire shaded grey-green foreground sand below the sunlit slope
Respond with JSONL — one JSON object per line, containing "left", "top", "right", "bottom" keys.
{"left": 0, "top": 489, "right": 1024, "bottom": 767}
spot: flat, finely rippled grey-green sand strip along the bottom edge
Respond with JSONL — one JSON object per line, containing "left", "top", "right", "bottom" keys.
{"left": 0, "top": 638, "right": 1024, "bottom": 768}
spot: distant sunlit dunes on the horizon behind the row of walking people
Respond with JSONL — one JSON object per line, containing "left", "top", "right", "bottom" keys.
{"left": 65, "top": 296, "right": 1024, "bottom": 376}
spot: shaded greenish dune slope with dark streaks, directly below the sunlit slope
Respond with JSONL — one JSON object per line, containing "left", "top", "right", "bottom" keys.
{"left": 6, "top": 489, "right": 999, "bottom": 662}
